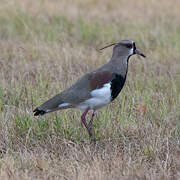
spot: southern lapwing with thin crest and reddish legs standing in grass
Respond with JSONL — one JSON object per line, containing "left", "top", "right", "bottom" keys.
{"left": 33, "top": 40, "right": 145, "bottom": 140}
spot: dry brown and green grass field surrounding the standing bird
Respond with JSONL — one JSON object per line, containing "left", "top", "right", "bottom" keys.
{"left": 0, "top": 0, "right": 180, "bottom": 180}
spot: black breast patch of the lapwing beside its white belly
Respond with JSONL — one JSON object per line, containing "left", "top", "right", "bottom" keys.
{"left": 111, "top": 73, "right": 126, "bottom": 101}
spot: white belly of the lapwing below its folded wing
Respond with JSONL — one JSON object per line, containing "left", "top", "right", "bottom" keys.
{"left": 77, "top": 83, "right": 111, "bottom": 110}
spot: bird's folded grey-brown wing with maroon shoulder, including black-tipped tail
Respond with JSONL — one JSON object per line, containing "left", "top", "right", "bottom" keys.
{"left": 34, "top": 71, "right": 112, "bottom": 115}
